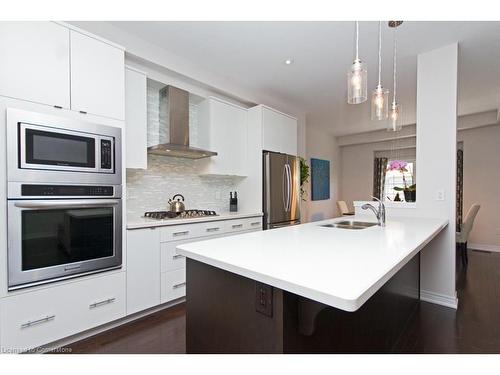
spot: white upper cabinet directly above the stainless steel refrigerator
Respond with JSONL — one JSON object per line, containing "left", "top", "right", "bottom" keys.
{"left": 262, "top": 107, "right": 297, "bottom": 155}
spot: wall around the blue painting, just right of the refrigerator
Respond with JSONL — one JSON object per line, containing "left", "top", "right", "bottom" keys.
{"left": 303, "top": 123, "right": 340, "bottom": 221}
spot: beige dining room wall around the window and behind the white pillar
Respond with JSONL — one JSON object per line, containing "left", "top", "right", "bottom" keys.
{"left": 339, "top": 123, "right": 500, "bottom": 251}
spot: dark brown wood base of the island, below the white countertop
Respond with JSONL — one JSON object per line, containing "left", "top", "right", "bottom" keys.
{"left": 186, "top": 254, "right": 420, "bottom": 353}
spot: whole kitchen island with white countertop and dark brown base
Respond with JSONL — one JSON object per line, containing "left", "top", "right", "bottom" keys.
{"left": 177, "top": 218, "right": 447, "bottom": 353}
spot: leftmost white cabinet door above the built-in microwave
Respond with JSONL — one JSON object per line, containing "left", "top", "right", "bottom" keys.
{"left": 0, "top": 22, "right": 70, "bottom": 108}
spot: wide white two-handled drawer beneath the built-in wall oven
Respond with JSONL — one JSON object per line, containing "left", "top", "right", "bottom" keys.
{"left": 0, "top": 272, "right": 125, "bottom": 351}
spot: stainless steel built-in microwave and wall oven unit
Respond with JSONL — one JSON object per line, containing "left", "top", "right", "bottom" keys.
{"left": 7, "top": 109, "right": 123, "bottom": 290}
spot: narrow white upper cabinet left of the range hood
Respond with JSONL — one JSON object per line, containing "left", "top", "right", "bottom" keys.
{"left": 125, "top": 67, "right": 148, "bottom": 169}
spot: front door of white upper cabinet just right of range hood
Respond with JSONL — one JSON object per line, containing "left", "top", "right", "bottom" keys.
{"left": 210, "top": 100, "right": 247, "bottom": 176}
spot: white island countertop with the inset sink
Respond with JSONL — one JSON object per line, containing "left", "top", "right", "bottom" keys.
{"left": 177, "top": 217, "right": 448, "bottom": 311}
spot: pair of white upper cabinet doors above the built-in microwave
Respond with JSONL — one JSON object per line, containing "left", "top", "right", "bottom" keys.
{"left": 0, "top": 21, "right": 125, "bottom": 120}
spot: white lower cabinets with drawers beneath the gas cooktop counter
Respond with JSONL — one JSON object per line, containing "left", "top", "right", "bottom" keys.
{"left": 127, "top": 216, "right": 262, "bottom": 314}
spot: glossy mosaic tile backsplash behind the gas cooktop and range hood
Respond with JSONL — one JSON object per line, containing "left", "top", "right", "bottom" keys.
{"left": 127, "top": 82, "right": 241, "bottom": 218}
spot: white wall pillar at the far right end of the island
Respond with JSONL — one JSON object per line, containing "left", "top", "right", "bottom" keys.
{"left": 415, "top": 43, "right": 458, "bottom": 306}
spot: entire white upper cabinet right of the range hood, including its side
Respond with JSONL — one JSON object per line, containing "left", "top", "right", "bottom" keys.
{"left": 198, "top": 97, "right": 247, "bottom": 176}
